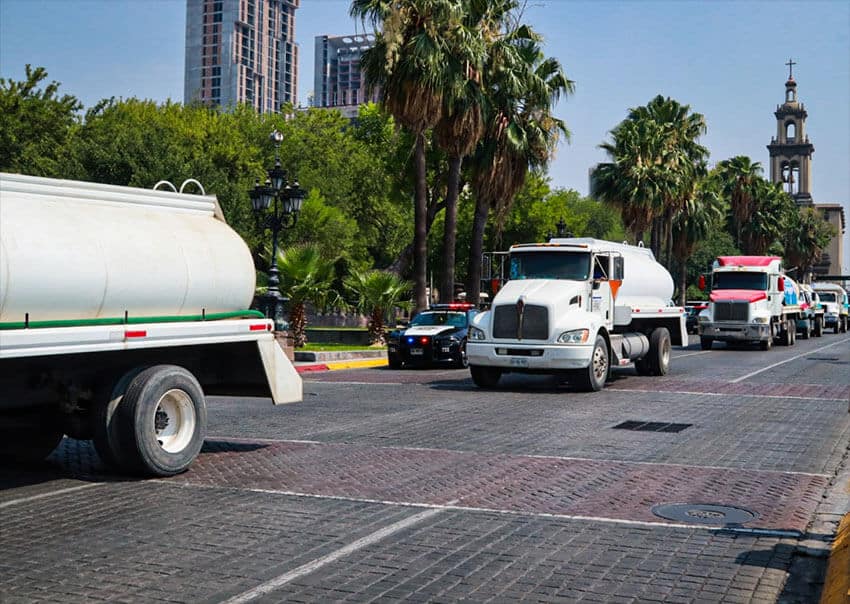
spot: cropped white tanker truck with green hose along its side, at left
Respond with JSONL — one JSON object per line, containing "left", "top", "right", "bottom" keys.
{"left": 0, "top": 174, "right": 302, "bottom": 476}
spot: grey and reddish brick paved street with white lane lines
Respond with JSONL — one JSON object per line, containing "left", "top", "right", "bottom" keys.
{"left": 0, "top": 335, "right": 850, "bottom": 604}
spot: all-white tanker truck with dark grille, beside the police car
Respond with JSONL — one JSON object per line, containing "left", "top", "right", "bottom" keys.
{"left": 467, "top": 238, "right": 688, "bottom": 391}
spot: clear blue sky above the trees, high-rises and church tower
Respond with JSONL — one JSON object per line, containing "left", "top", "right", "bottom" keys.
{"left": 0, "top": 0, "right": 850, "bottom": 271}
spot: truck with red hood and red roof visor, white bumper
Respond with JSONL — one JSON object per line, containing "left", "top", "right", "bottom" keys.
{"left": 699, "top": 256, "right": 802, "bottom": 350}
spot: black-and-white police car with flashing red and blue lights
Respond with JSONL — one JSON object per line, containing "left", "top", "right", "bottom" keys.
{"left": 387, "top": 303, "right": 477, "bottom": 369}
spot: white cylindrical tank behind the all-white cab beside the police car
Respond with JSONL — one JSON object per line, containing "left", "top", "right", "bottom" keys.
{"left": 551, "top": 237, "right": 674, "bottom": 307}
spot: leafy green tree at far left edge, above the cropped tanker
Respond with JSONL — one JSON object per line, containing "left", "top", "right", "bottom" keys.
{"left": 0, "top": 65, "right": 82, "bottom": 177}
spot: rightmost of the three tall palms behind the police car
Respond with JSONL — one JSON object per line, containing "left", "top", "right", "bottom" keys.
{"left": 460, "top": 23, "right": 573, "bottom": 303}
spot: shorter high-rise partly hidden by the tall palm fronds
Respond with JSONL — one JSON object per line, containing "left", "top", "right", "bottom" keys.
{"left": 312, "top": 34, "right": 380, "bottom": 117}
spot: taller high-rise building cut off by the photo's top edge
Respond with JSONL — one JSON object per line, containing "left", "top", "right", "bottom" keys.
{"left": 183, "top": 0, "right": 301, "bottom": 113}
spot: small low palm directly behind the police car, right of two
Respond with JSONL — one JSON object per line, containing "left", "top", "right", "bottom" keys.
{"left": 345, "top": 270, "right": 411, "bottom": 345}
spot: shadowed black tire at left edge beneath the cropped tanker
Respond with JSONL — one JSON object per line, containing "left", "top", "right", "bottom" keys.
{"left": 0, "top": 408, "right": 64, "bottom": 465}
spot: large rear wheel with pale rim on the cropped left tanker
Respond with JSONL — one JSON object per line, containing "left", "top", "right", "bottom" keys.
{"left": 116, "top": 365, "right": 207, "bottom": 476}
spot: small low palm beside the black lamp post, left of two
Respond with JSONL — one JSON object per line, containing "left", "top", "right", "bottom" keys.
{"left": 277, "top": 244, "right": 342, "bottom": 348}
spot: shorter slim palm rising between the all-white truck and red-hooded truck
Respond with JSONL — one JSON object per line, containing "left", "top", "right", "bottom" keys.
{"left": 671, "top": 177, "right": 723, "bottom": 306}
